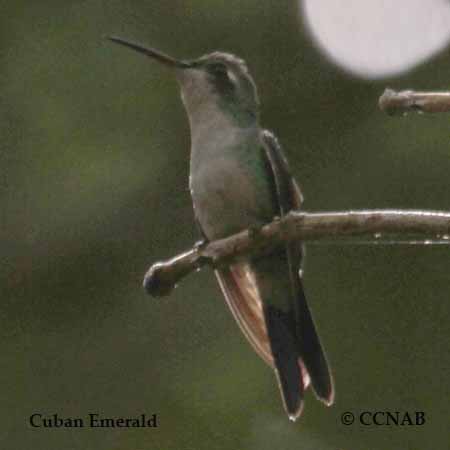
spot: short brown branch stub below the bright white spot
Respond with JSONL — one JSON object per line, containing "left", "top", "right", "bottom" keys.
{"left": 378, "top": 89, "right": 450, "bottom": 115}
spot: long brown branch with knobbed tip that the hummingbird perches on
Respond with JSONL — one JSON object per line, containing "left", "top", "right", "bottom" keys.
{"left": 144, "top": 210, "right": 450, "bottom": 297}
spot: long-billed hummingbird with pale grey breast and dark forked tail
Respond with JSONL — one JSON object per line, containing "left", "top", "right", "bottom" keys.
{"left": 108, "top": 36, "right": 334, "bottom": 421}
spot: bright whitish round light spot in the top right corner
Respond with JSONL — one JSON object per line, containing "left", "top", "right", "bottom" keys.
{"left": 299, "top": 0, "right": 450, "bottom": 78}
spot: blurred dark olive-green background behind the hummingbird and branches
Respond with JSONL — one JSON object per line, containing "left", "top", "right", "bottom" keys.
{"left": 0, "top": 0, "right": 450, "bottom": 450}
